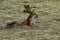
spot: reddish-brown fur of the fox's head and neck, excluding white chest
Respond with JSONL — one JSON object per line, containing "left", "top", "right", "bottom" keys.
{"left": 22, "top": 5, "right": 38, "bottom": 26}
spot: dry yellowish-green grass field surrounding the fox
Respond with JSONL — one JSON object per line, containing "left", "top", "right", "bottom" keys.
{"left": 0, "top": 0, "right": 60, "bottom": 40}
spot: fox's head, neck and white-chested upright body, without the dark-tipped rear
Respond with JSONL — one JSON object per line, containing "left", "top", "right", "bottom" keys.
{"left": 21, "top": 5, "right": 38, "bottom": 26}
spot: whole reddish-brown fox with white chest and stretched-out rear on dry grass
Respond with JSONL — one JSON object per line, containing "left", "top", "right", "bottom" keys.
{"left": 0, "top": 5, "right": 38, "bottom": 30}
